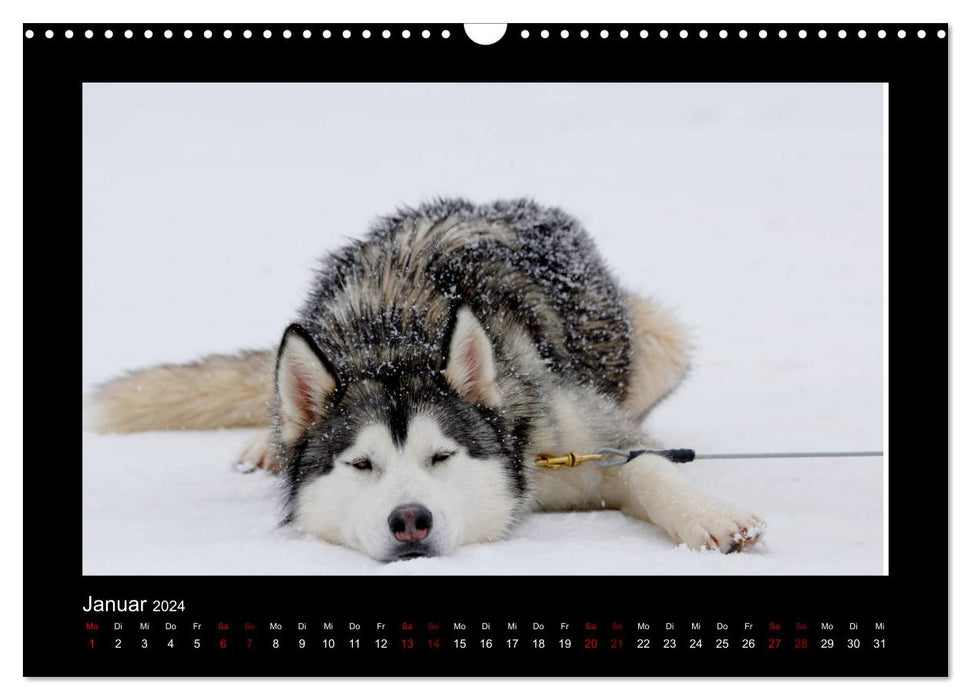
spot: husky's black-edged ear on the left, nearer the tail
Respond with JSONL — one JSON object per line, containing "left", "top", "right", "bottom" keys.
{"left": 276, "top": 323, "right": 337, "bottom": 443}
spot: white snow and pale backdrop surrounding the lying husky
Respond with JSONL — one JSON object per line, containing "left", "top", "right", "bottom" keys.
{"left": 82, "top": 84, "right": 885, "bottom": 575}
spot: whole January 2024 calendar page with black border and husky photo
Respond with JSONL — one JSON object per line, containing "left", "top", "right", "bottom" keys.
{"left": 23, "top": 23, "right": 948, "bottom": 676}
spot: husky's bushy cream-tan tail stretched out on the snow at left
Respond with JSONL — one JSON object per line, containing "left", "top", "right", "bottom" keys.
{"left": 84, "top": 350, "right": 276, "bottom": 433}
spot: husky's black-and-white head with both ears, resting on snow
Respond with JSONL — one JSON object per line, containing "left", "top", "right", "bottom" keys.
{"left": 276, "top": 308, "right": 525, "bottom": 561}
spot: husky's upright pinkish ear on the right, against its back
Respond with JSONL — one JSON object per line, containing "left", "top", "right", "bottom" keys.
{"left": 444, "top": 306, "right": 501, "bottom": 408}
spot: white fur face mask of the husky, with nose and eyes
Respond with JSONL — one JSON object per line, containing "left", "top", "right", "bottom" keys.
{"left": 293, "top": 413, "right": 516, "bottom": 561}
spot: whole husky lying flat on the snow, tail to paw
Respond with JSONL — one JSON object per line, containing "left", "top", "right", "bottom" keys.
{"left": 89, "top": 200, "right": 765, "bottom": 561}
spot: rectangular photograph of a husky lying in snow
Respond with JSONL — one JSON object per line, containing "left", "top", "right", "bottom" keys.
{"left": 80, "top": 83, "right": 888, "bottom": 576}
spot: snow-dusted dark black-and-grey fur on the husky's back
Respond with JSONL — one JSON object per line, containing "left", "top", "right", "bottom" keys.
{"left": 300, "top": 200, "right": 631, "bottom": 401}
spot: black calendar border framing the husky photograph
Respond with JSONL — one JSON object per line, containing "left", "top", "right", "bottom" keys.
{"left": 23, "top": 23, "right": 949, "bottom": 676}
